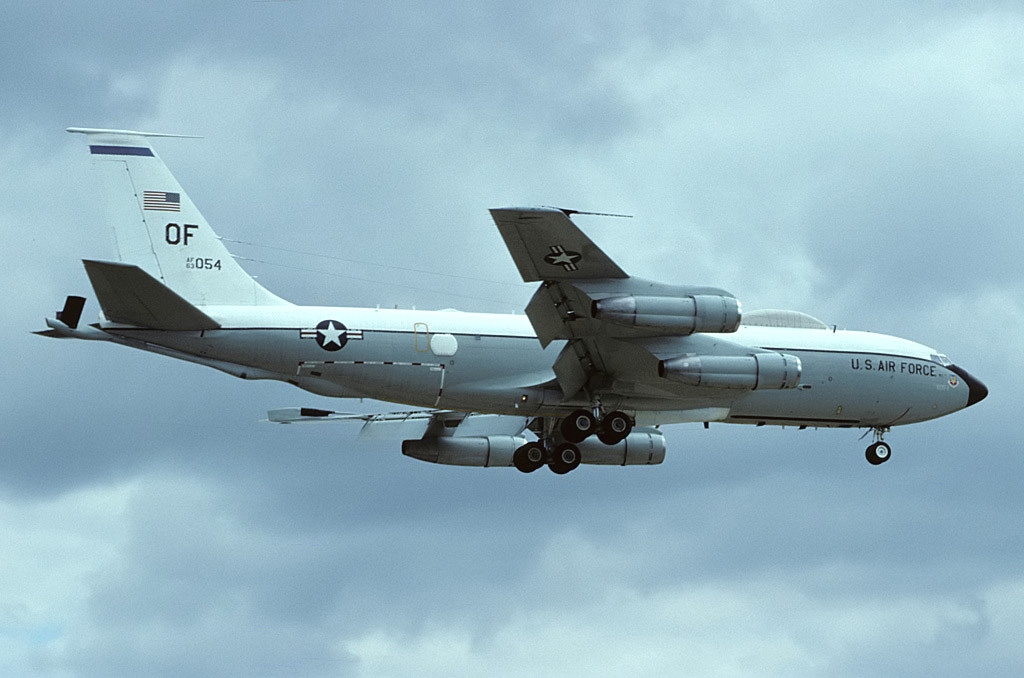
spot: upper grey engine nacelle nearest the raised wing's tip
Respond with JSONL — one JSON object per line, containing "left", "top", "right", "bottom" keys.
{"left": 591, "top": 294, "right": 742, "bottom": 334}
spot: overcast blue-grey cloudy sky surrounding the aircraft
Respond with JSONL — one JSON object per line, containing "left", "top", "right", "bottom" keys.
{"left": 0, "top": 0, "right": 1024, "bottom": 678}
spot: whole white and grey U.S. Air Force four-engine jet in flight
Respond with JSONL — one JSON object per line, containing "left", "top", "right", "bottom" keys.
{"left": 39, "top": 128, "right": 988, "bottom": 473}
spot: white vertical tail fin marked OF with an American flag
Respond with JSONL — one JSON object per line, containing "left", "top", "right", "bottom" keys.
{"left": 68, "top": 127, "right": 288, "bottom": 307}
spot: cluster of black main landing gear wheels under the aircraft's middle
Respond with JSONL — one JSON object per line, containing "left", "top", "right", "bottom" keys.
{"left": 512, "top": 410, "right": 633, "bottom": 474}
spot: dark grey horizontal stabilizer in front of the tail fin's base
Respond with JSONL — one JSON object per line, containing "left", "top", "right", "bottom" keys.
{"left": 82, "top": 260, "right": 220, "bottom": 331}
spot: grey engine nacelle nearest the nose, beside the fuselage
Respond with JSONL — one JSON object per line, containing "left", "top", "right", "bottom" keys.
{"left": 657, "top": 352, "right": 801, "bottom": 390}
